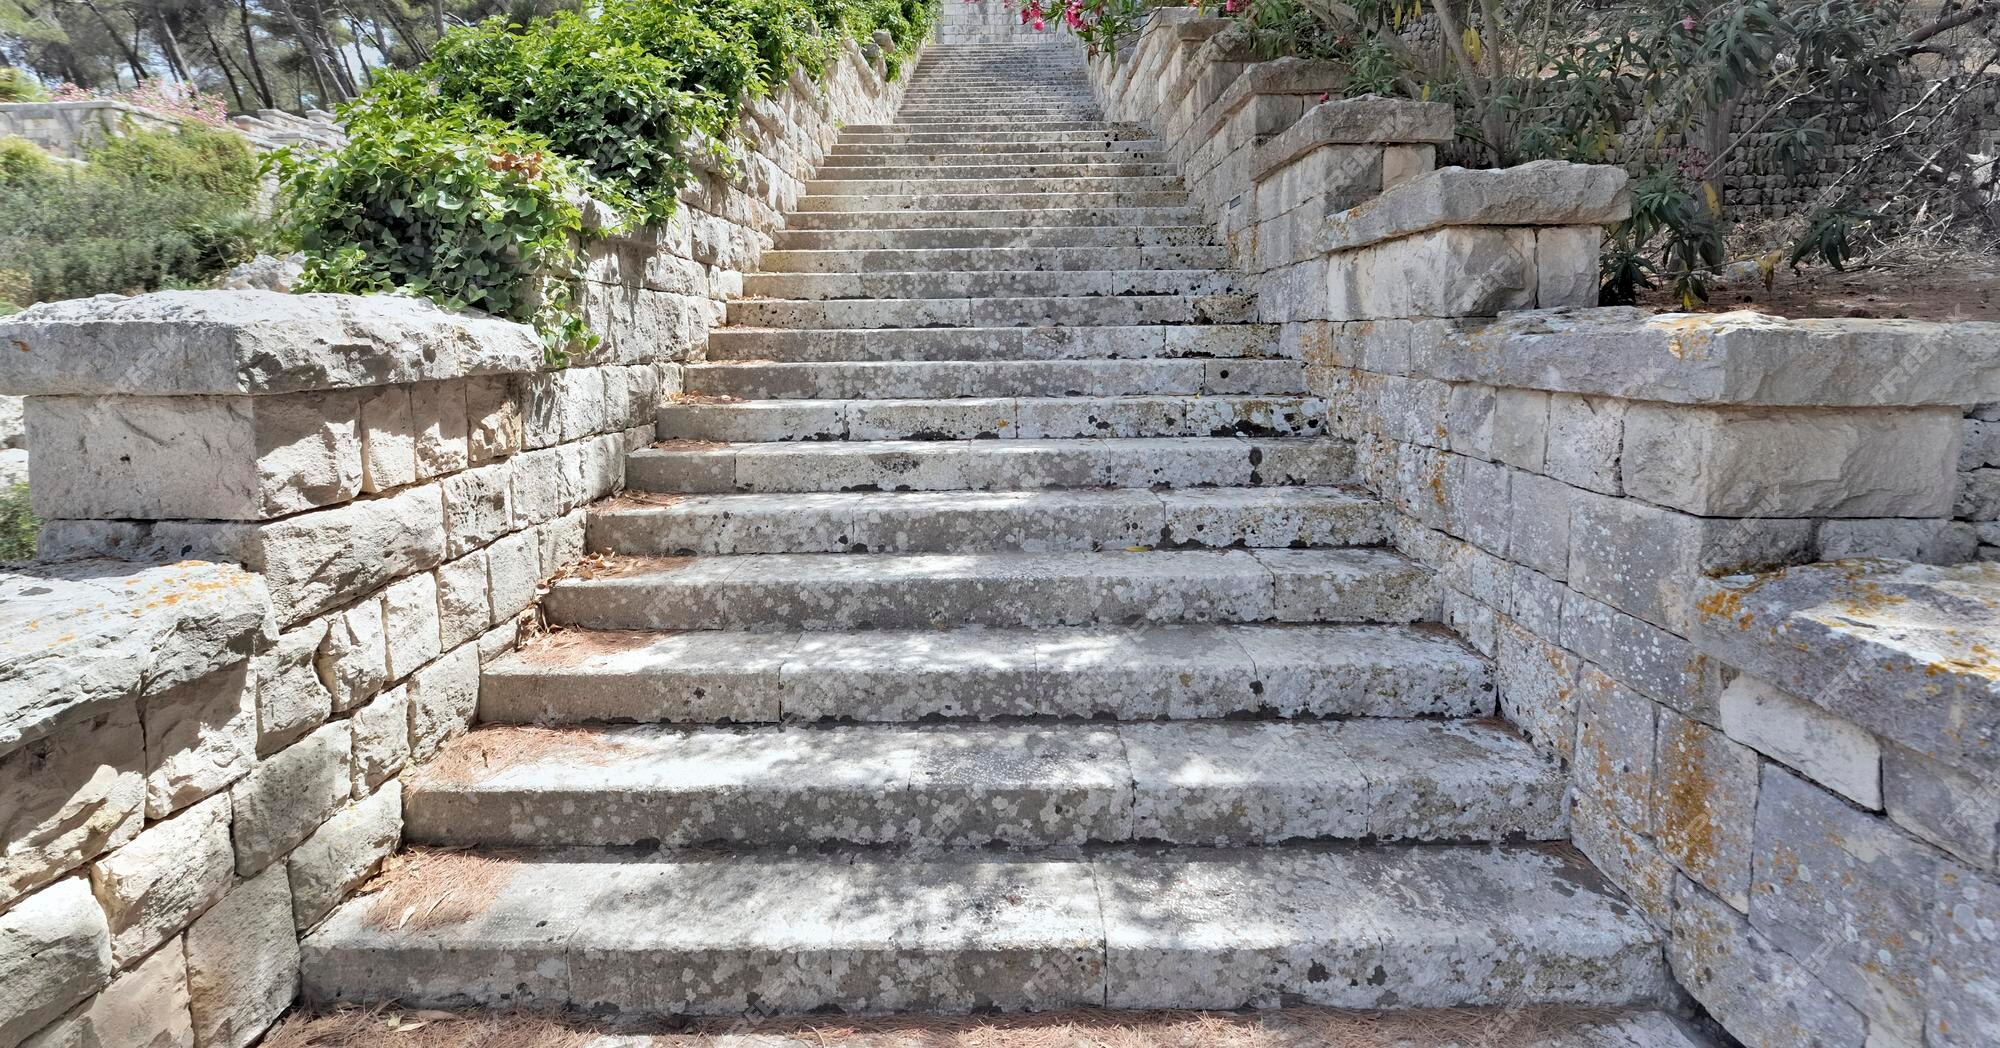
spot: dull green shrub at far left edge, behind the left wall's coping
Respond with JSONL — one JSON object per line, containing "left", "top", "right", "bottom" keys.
{"left": 0, "top": 128, "right": 260, "bottom": 304}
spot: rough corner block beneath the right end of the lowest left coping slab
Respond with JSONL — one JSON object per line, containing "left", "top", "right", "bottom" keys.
{"left": 140, "top": 662, "right": 256, "bottom": 818}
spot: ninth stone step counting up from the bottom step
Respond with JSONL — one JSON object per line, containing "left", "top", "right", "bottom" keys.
{"left": 708, "top": 324, "right": 1264, "bottom": 362}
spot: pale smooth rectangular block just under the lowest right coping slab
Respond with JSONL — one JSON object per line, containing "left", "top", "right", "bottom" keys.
{"left": 1722, "top": 674, "right": 1882, "bottom": 810}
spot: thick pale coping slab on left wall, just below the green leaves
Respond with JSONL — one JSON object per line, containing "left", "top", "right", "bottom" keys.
{"left": 0, "top": 290, "right": 542, "bottom": 396}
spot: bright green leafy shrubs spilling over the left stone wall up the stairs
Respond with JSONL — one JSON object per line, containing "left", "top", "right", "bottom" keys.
{"left": 272, "top": 0, "right": 938, "bottom": 358}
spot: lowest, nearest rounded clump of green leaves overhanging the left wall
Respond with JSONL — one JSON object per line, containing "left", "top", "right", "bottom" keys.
{"left": 274, "top": 98, "right": 582, "bottom": 356}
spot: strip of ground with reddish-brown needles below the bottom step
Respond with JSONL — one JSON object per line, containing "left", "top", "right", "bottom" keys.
{"left": 264, "top": 1008, "right": 1704, "bottom": 1048}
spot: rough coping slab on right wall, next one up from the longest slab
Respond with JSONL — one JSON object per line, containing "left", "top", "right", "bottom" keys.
{"left": 1318, "top": 160, "right": 1632, "bottom": 252}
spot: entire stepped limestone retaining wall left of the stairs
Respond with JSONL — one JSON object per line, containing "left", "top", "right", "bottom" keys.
{"left": 0, "top": 34, "right": 900, "bottom": 1048}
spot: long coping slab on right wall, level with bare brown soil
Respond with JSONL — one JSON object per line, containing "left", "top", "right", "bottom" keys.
{"left": 1400, "top": 306, "right": 2000, "bottom": 408}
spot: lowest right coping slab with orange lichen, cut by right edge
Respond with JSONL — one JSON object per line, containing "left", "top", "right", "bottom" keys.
{"left": 1692, "top": 558, "right": 2000, "bottom": 782}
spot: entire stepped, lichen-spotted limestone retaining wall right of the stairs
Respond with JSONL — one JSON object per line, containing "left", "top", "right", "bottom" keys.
{"left": 1094, "top": 10, "right": 2000, "bottom": 1046}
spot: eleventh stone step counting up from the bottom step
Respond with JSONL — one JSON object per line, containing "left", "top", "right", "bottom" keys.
{"left": 742, "top": 268, "right": 1242, "bottom": 302}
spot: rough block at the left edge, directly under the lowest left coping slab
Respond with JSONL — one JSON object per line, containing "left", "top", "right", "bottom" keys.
{"left": 0, "top": 706, "right": 146, "bottom": 908}
